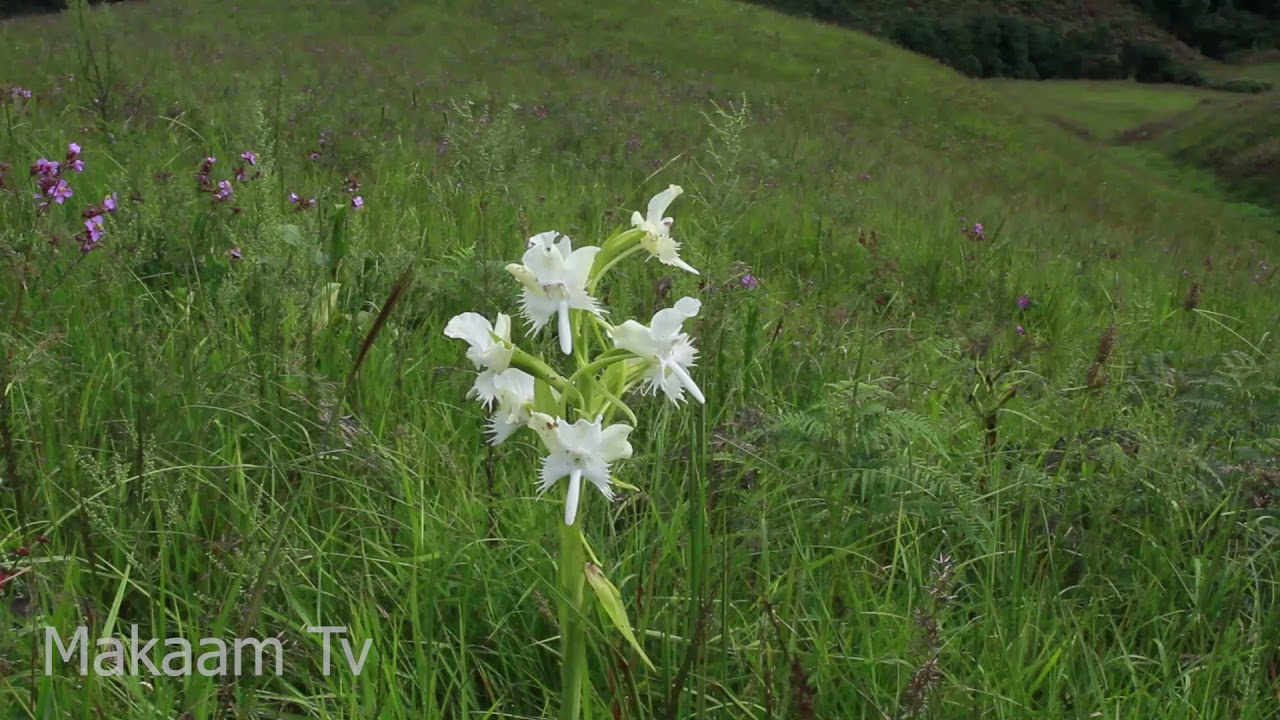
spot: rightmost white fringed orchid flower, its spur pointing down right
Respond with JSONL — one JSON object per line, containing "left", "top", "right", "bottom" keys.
{"left": 609, "top": 297, "right": 707, "bottom": 405}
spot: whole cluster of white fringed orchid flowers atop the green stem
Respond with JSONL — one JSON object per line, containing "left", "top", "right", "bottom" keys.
{"left": 444, "top": 184, "right": 707, "bottom": 525}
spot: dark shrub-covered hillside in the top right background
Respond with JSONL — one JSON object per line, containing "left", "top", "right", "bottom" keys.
{"left": 751, "top": 0, "right": 1280, "bottom": 86}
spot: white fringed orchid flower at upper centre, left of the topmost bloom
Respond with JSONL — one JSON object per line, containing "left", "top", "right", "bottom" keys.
{"left": 507, "top": 231, "right": 603, "bottom": 355}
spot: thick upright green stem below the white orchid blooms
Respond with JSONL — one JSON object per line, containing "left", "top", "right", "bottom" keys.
{"left": 559, "top": 514, "right": 586, "bottom": 720}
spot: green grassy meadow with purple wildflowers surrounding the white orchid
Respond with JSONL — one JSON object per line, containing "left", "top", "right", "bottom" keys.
{"left": 0, "top": 0, "right": 1280, "bottom": 720}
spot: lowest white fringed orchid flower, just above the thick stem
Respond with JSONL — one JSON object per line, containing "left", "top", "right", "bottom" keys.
{"left": 529, "top": 413, "right": 632, "bottom": 525}
